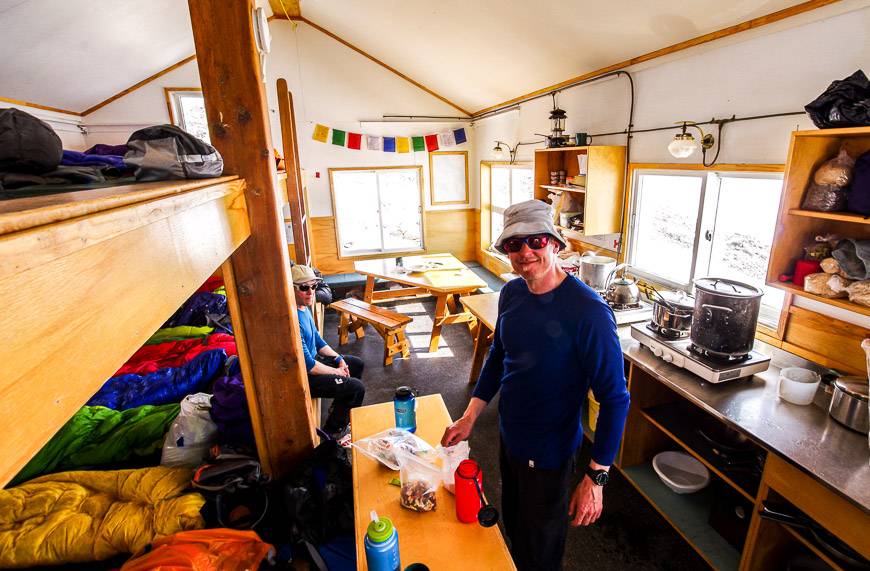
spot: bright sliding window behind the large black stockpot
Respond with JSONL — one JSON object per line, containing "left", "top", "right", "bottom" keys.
{"left": 628, "top": 170, "right": 784, "bottom": 328}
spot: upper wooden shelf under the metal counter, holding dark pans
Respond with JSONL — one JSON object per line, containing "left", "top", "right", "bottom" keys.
{"left": 640, "top": 402, "right": 761, "bottom": 503}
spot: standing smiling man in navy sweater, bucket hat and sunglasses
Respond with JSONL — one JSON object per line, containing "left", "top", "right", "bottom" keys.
{"left": 441, "top": 200, "right": 629, "bottom": 571}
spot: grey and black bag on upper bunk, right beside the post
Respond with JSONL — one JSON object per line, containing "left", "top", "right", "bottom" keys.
{"left": 124, "top": 125, "right": 224, "bottom": 181}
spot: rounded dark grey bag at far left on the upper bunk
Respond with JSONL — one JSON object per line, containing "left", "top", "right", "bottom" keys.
{"left": 0, "top": 108, "right": 63, "bottom": 174}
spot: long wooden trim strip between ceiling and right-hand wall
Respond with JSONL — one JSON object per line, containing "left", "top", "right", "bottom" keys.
{"left": 471, "top": 0, "right": 840, "bottom": 117}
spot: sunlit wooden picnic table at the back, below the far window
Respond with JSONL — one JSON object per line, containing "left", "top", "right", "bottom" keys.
{"left": 353, "top": 254, "right": 486, "bottom": 353}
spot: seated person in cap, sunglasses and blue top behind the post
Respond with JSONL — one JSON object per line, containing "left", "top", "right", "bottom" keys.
{"left": 290, "top": 265, "right": 366, "bottom": 438}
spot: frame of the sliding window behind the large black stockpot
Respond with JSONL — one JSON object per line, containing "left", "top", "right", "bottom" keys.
{"left": 623, "top": 163, "right": 790, "bottom": 339}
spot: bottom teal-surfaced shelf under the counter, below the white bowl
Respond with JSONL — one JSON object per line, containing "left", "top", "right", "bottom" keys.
{"left": 622, "top": 463, "right": 740, "bottom": 570}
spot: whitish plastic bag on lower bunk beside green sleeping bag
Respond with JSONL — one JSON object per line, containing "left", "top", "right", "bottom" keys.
{"left": 160, "top": 393, "right": 218, "bottom": 468}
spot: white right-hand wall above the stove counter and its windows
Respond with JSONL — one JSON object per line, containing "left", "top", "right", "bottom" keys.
{"left": 472, "top": 4, "right": 870, "bottom": 327}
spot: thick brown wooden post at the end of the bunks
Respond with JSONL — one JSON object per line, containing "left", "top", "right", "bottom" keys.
{"left": 188, "top": 0, "right": 315, "bottom": 476}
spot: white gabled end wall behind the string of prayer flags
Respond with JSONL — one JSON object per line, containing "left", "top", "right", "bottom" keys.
{"left": 84, "top": 20, "right": 476, "bottom": 216}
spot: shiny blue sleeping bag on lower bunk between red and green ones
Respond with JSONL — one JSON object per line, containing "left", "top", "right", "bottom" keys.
{"left": 87, "top": 349, "right": 227, "bottom": 410}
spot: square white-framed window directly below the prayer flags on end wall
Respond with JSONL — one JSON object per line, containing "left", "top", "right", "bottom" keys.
{"left": 329, "top": 166, "right": 423, "bottom": 256}
